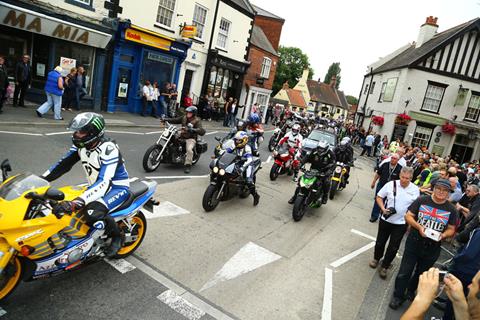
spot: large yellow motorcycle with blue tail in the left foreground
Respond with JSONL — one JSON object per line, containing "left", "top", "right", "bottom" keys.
{"left": 0, "top": 160, "right": 158, "bottom": 301}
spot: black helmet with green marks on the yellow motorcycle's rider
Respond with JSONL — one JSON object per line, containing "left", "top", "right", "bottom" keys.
{"left": 68, "top": 112, "right": 105, "bottom": 149}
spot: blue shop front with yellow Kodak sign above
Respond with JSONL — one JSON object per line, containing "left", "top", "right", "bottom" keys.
{"left": 107, "top": 23, "right": 190, "bottom": 113}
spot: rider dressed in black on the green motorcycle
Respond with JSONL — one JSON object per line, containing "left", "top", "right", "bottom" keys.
{"left": 288, "top": 140, "right": 335, "bottom": 204}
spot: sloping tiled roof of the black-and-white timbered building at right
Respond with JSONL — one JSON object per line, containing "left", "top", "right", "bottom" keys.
{"left": 373, "top": 18, "right": 480, "bottom": 73}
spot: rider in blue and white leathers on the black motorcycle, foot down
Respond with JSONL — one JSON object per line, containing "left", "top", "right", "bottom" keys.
{"left": 225, "top": 131, "right": 260, "bottom": 206}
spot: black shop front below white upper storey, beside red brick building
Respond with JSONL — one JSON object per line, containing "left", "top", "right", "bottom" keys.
{"left": 202, "top": 49, "right": 249, "bottom": 101}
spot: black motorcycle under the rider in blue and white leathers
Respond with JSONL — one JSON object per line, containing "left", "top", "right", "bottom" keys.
{"left": 202, "top": 152, "right": 261, "bottom": 212}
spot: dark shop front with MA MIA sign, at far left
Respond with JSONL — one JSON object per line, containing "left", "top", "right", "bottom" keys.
{"left": 0, "top": 2, "right": 113, "bottom": 108}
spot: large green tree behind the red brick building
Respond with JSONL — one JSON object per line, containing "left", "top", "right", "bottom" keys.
{"left": 272, "top": 46, "right": 314, "bottom": 94}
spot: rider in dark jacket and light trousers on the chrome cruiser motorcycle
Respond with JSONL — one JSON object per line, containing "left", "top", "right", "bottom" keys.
{"left": 162, "top": 106, "right": 205, "bottom": 173}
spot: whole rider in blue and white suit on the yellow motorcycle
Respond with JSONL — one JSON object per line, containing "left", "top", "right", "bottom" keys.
{"left": 42, "top": 112, "right": 130, "bottom": 257}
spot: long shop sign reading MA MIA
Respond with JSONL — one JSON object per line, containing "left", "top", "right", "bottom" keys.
{"left": 0, "top": 3, "right": 112, "bottom": 48}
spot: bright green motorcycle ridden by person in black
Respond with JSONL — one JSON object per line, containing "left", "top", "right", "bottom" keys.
{"left": 292, "top": 169, "right": 325, "bottom": 221}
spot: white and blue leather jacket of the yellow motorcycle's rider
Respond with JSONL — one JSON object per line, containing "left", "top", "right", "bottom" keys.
{"left": 42, "top": 140, "right": 130, "bottom": 204}
